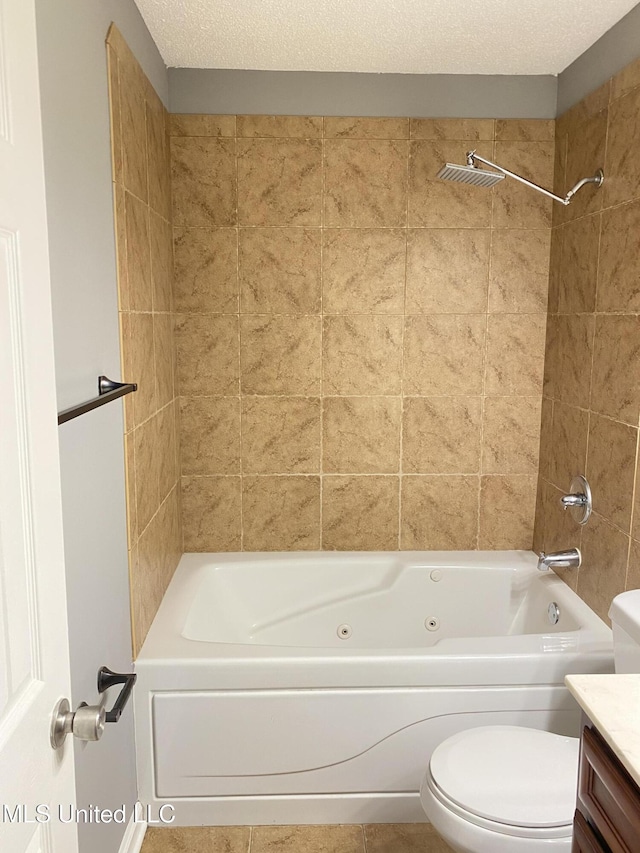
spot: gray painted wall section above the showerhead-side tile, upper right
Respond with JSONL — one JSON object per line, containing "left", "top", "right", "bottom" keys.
{"left": 558, "top": 4, "right": 640, "bottom": 116}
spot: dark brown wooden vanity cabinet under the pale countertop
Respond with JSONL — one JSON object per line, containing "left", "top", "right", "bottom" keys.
{"left": 572, "top": 721, "right": 640, "bottom": 853}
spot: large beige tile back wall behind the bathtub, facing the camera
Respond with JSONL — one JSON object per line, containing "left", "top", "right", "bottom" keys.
{"left": 170, "top": 115, "right": 554, "bottom": 551}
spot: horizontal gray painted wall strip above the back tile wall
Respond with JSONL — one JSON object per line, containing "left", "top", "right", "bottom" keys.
{"left": 169, "top": 68, "right": 557, "bottom": 118}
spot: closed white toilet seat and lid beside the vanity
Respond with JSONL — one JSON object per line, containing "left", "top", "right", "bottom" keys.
{"left": 425, "top": 726, "right": 579, "bottom": 839}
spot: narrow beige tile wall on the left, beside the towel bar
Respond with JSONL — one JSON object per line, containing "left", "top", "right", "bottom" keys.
{"left": 107, "top": 25, "right": 182, "bottom": 655}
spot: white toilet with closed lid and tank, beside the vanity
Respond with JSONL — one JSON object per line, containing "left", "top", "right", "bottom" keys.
{"left": 420, "top": 590, "right": 640, "bottom": 853}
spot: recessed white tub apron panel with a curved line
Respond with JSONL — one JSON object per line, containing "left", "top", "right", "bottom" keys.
{"left": 153, "top": 687, "right": 579, "bottom": 798}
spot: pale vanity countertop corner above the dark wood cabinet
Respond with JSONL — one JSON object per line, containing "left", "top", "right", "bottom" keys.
{"left": 565, "top": 674, "right": 640, "bottom": 786}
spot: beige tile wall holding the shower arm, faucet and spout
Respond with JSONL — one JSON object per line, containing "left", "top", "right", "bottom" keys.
{"left": 535, "top": 61, "right": 640, "bottom": 618}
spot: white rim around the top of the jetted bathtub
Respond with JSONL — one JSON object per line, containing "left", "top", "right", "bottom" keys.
{"left": 136, "top": 551, "right": 613, "bottom": 689}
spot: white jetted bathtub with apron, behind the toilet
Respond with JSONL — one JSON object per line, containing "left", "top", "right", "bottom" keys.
{"left": 134, "top": 551, "right": 613, "bottom": 825}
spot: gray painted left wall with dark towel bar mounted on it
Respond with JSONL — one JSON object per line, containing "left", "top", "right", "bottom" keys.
{"left": 36, "top": 0, "right": 168, "bottom": 853}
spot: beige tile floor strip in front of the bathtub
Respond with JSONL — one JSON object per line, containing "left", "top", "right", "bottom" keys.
{"left": 141, "top": 823, "right": 452, "bottom": 853}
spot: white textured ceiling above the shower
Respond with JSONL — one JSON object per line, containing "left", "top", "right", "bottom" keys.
{"left": 136, "top": 0, "right": 637, "bottom": 74}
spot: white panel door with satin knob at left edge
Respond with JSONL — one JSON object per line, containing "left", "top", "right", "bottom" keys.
{"left": 0, "top": 0, "right": 77, "bottom": 853}
